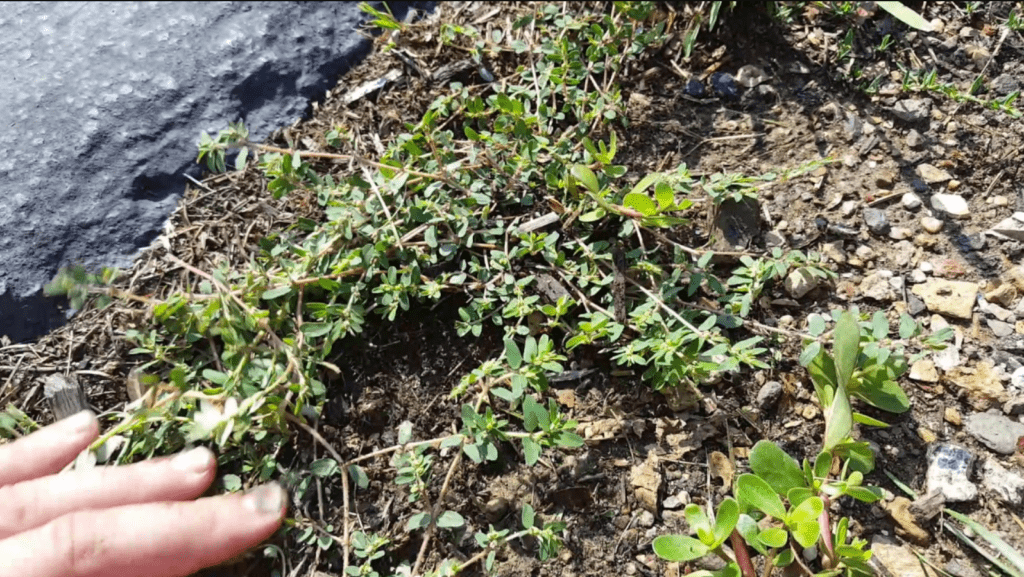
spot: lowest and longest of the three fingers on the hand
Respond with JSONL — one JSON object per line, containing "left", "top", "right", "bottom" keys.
{"left": 0, "top": 484, "right": 287, "bottom": 577}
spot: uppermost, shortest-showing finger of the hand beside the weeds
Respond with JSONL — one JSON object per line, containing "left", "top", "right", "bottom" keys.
{"left": 0, "top": 411, "right": 99, "bottom": 487}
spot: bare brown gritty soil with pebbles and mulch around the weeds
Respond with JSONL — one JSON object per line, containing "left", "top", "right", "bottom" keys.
{"left": 0, "top": 3, "right": 1024, "bottom": 576}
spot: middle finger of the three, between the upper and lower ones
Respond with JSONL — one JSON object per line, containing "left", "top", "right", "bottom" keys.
{"left": 0, "top": 447, "right": 216, "bottom": 539}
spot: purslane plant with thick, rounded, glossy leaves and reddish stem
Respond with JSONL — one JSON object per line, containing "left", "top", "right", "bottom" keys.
{"left": 653, "top": 310, "right": 950, "bottom": 577}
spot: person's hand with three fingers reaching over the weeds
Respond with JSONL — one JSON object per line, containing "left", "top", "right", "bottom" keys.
{"left": 0, "top": 411, "right": 287, "bottom": 577}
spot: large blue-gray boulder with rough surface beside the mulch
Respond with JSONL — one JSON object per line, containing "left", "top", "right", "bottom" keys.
{"left": 0, "top": 2, "right": 428, "bottom": 340}
